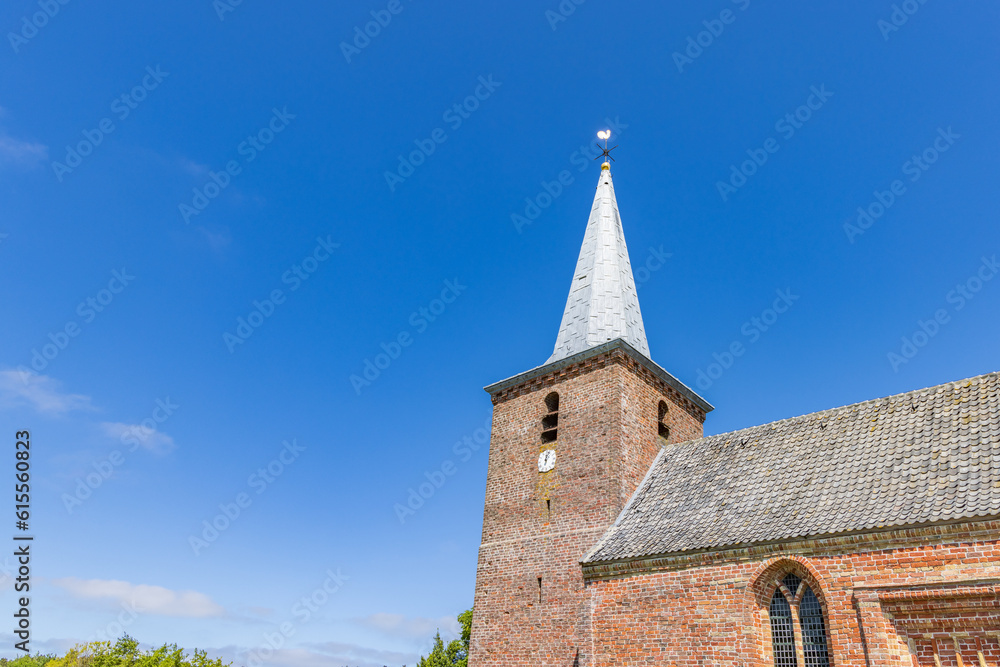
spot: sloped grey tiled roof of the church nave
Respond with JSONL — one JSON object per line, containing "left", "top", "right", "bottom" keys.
{"left": 584, "top": 373, "right": 1000, "bottom": 563}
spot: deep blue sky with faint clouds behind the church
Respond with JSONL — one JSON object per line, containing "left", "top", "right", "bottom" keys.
{"left": 0, "top": 0, "right": 1000, "bottom": 666}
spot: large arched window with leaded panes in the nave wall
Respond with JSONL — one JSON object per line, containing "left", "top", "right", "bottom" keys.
{"left": 768, "top": 573, "right": 830, "bottom": 667}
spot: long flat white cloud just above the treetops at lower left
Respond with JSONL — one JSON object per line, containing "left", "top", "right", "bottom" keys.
{"left": 52, "top": 577, "right": 225, "bottom": 618}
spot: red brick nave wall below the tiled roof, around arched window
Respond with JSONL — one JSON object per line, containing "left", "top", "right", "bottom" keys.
{"left": 581, "top": 522, "right": 1000, "bottom": 667}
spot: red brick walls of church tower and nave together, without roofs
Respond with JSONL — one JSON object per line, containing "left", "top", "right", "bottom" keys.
{"left": 469, "top": 342, "right": 1000, "bottom": 667}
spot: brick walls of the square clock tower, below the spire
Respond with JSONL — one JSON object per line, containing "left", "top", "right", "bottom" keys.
{"left": 469, "top": 349, "right": 705, "bottom": 667}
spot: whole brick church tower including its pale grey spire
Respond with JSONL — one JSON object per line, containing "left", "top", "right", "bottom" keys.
{"left": 469, "top": 162, "right": 712, "bottom": 667}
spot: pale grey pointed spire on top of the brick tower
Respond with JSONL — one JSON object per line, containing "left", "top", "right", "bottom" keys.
{"left": 546, "top": 162, "right": 649, "bottom": 363}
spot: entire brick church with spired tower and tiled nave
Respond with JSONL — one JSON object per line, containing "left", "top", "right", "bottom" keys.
{"left": 469, "top": 155, "right": 1000, "bottom": 667}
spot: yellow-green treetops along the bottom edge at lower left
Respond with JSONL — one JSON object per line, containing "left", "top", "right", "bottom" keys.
{"left": 37, "top": 635, "right": 231, "bottom": 667}
